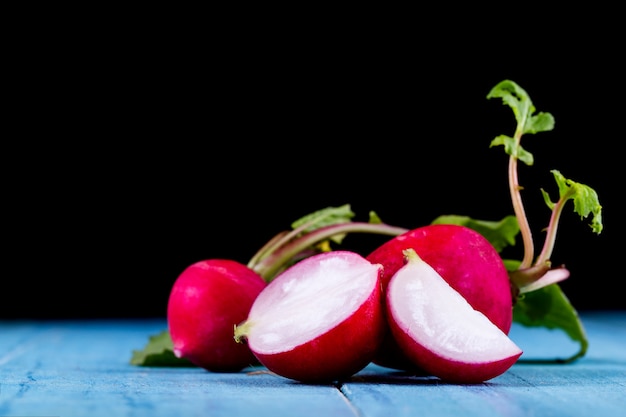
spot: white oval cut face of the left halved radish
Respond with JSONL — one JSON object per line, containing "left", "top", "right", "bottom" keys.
{"left": 247, "top": 253, "right": 380, "bottom": 354}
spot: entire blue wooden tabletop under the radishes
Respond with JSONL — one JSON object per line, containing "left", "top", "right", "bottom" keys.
{"left": 0, "top": 311, "right": 626, "bottom": 417}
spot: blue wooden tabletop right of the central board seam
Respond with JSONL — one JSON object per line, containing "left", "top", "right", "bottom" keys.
{"left": 341, "top": 312, "right": 626, "bottom": 417}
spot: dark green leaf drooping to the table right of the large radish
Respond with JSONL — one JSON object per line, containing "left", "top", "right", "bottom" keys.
{"left": 513, "top": 284, "right": 589, "bottom": 362}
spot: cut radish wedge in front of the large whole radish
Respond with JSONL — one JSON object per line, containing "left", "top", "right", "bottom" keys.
{"left": 385, "top": 249, "right": 522, "bottom": 383}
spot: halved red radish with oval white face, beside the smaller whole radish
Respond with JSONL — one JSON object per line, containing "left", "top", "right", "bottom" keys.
{"left": 235, "top": 251, "right": 386, "bottom": 383}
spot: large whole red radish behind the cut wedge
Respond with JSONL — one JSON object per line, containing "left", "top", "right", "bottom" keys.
{"left": 366, "top": 224, "right": 513, "bottom": 370}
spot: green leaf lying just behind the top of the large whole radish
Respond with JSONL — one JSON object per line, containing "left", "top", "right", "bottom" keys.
{"left": 432, "top": 215, "right": 519, "bottom": 252}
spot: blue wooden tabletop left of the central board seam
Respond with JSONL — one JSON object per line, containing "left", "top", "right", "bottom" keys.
{"left": 0, "top": 321, "right": 355, "bottom": 417}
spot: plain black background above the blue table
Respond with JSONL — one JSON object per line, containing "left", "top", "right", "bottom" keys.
{"left": 0, "top": 15, "right": 626, "bottom": 319}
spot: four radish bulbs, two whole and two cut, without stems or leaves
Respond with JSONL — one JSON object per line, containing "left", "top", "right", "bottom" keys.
{"left": 168, "top": 219, "right": 522, "bottom": 383}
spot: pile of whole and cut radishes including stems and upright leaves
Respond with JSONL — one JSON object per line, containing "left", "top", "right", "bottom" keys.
{"left": 167, "top": 81, "right": 602, "bottom": 383}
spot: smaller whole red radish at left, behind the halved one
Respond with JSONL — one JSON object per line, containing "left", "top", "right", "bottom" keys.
{"left": 167, "top": 259, "right": 267, "bottom": 372}
